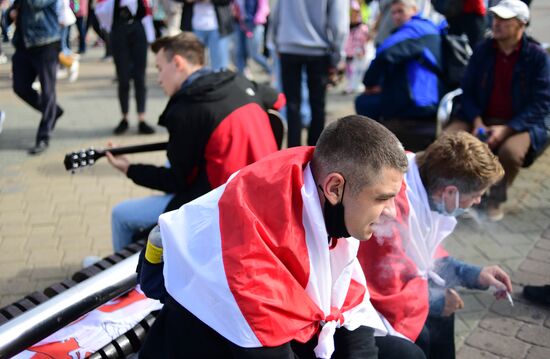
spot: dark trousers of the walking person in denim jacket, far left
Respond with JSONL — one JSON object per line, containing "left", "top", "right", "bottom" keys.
{"left": 12, "top": 43, "right": 61, "bottom": 143}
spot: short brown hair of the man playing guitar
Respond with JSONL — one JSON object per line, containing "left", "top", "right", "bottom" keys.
{"left": 151, "top": 32, "right": 204, "bottom": 66}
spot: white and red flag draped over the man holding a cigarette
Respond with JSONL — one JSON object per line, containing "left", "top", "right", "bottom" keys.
{"left": 357, "top": 153, "right": 456, "bottom": 341}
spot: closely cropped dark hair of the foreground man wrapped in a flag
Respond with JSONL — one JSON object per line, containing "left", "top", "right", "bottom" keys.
{"left": 312, "top": 115, "right": 408, "bottom": 193}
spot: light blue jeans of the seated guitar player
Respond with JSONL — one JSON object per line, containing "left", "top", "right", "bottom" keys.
{"left": 111, "top": 194, "right": 174, "bottom": 252}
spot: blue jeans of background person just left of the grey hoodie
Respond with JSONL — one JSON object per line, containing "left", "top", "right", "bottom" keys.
{"left": 235, "top": 23, "right": 271, "bottom": 74}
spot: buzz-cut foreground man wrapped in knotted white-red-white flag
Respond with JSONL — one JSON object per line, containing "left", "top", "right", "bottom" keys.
{"left": 136, "top": 116, "right": 430, "bottom": 358}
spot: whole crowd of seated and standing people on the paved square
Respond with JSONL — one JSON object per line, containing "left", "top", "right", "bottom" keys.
{"left": 0, "top": 0, "right": 550, "bottom": 358}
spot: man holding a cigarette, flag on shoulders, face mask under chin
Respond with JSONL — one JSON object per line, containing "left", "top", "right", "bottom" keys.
{"left": 357, "top": 131, "right": 512, "bottom": 359}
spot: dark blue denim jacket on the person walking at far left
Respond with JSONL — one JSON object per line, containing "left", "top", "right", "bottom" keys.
{"left": 12, "top": 0, "right": 61, "bottom": 48}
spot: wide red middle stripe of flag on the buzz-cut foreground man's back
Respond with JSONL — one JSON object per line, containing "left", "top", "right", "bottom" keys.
{"left": 219, "top": 147, "right": 324, "bottom": 346}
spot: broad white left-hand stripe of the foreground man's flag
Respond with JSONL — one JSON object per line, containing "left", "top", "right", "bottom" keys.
{"left": 159, "top": 185, "right": 261, "bottom": 348}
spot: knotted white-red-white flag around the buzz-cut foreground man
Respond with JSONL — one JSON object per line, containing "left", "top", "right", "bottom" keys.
{"left": 159, "top": 147, "right": 385, "bottom": 358}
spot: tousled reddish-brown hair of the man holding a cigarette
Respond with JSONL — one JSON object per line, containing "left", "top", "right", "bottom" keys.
{"left": 416, "top": 131, "right": 504, "bottom": 194}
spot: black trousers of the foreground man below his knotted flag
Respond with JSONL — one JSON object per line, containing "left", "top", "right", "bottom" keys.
{"left": 139, "top": 297, "right": 425, "bottom": 359}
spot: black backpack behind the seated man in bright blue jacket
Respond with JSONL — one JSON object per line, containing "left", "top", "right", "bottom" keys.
{"left": 441, "top": 32, "right": 472, "bottom": 90}
